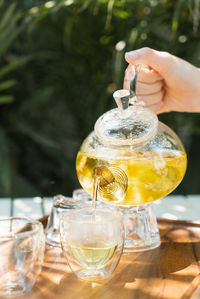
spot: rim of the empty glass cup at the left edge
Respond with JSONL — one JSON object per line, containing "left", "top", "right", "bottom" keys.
{"left": 0, "top": 216, "right": 43, "bottom": 241}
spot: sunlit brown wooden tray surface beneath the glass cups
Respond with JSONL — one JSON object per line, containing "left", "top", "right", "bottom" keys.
{"left": 3, "top": 219, "right": 200, "bottom": 299}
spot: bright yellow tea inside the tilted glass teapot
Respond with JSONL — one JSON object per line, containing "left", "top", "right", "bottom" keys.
{"left": 76, "top": 150, "right": 187, "bottom": 205}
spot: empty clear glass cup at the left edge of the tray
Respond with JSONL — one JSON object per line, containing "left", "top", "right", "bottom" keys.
{"left": 0, "top": 217, "right": 45, "bottom": 296}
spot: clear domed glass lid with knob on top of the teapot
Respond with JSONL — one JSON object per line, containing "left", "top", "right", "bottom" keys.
{"left": 95, "top": 89, "right": 158, "bottom": 146}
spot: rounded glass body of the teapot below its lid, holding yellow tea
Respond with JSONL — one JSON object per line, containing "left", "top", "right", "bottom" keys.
{"left": 76, "top": 117, "right": 187, "bottom": 206}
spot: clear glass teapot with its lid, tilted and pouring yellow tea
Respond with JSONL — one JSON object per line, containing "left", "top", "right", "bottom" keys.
{"left": 76, "top": 70, "right": 187, "bottom": 207}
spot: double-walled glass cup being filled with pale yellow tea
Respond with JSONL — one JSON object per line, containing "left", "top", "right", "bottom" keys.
{"left": 60, "top": 208, "right": 124, "bottom": 281}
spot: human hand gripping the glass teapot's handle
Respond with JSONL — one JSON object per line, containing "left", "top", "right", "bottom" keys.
{"left": 124, "top": 48, "right": 200, "bottom": 113}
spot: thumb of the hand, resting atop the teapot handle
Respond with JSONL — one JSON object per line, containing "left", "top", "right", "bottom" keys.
{"left": 125, "top": 48, "right": 173, "bottom": 77}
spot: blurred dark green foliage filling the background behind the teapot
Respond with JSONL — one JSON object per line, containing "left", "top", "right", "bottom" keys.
{"left": 0, "top": 0, "right": 200, "bottom": 196}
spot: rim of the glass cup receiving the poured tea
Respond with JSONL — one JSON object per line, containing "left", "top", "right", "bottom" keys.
{"left": 61, "top": 207, "right": 123, "bottom": 224}
